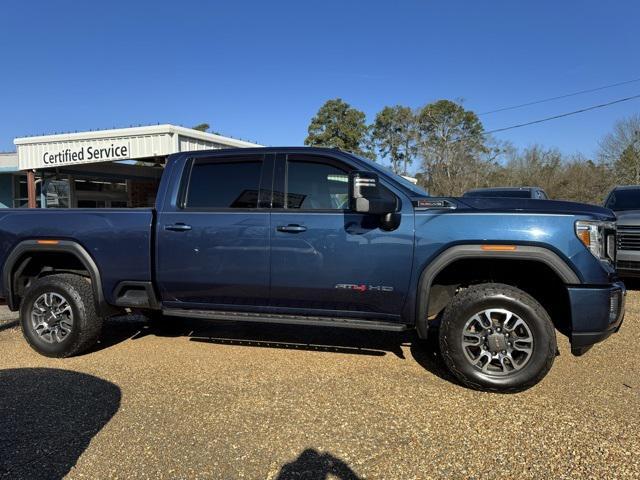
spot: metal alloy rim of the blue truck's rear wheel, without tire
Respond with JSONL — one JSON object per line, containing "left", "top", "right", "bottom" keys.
{"left": 31, "top": 292, "right": 73, "bottom": 343}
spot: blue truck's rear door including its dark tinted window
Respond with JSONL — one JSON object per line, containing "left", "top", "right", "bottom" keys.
{"left": 156, "top": 154, "right": 273, "bottom": 309}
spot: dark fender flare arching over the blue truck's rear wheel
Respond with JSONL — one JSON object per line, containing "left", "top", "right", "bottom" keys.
{"left": 2, "top": 240, "right": 109, "bottom": 313}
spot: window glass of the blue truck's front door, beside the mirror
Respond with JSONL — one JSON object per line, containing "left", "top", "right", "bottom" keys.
{"left": 286, "top": 160, "right": 349, "bottom": 210}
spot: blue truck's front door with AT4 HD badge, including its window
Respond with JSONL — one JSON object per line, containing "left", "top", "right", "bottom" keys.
{"left": 270, "top": 154, "right": 414, "bottom": 319}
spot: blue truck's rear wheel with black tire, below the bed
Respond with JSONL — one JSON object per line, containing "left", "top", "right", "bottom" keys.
{"left": 20, "top": 274, "right": 102, "bottom": 357}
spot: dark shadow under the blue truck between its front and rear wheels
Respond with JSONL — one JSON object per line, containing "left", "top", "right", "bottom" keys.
{"left": 96, "top": 316, "right": 458, "bottom": 384}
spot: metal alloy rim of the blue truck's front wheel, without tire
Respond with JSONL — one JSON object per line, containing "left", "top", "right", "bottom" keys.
{"left": 462, "top": 308, "right": 533, "bottom": 376}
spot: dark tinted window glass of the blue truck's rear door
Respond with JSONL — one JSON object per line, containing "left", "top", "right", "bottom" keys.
{"left": 186, "top": 160, "right": 262, "bottom": 208}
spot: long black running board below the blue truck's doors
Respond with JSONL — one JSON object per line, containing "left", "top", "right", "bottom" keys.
{"left": 162, "top": 308, "right": 408, "bottom": 332}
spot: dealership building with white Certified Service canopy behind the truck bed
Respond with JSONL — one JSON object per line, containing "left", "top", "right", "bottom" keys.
{"left": 0, "top": 125, "right": 260, "bottom": 208}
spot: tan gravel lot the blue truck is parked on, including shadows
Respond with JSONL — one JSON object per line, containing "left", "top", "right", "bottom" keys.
{"left": 0, "top": 292, "right": 640, "bottom": 480}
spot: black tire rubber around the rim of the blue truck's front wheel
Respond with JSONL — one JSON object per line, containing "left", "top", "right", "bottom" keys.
{"left": 439, "top": 283, "right": 557, "bottom": 393}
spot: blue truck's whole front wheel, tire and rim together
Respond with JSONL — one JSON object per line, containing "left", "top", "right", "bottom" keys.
{"left": 439, "top": 283, "right": 557, "bottom": 393}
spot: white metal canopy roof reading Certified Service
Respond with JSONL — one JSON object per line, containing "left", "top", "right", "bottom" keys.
{"left": 13, "top": 124, "right": 260, "bottom": 170}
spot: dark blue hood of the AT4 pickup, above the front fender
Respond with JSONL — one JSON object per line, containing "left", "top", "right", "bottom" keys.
{"left": 440, "top": 197, "right": 616, "bottom": 221}
